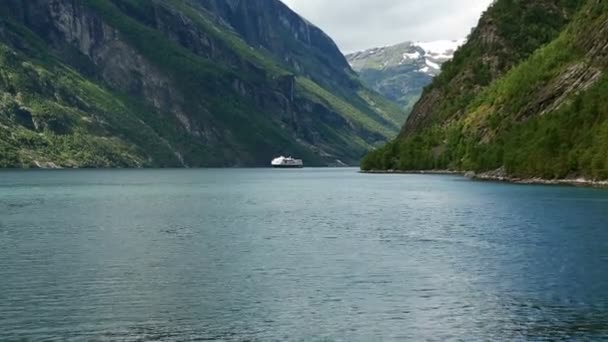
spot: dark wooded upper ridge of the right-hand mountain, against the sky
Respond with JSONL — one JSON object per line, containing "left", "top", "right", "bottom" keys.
{"left": 412, "top": 0, "right": 581, "bottom": 127}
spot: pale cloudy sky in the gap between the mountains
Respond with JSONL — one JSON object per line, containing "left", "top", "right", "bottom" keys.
{"left": 282, "top": 0, "right": 492, "bottom": 53}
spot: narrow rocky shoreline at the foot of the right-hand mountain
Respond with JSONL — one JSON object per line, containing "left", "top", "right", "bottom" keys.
{"left": 360, "top": 170, "right": 608, "bottom": 189}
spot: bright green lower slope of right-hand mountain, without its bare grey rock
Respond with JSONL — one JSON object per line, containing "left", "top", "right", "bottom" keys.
{"left": 363, "top": 0, "right": 608, "bottom": 179}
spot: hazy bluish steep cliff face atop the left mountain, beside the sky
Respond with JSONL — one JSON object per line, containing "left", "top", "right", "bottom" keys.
{"left": 194, "top": 0, "right": 359, "bottom": 89}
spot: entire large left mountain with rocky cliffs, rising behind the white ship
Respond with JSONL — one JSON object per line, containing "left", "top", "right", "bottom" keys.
{"left": 0, "top": 0, "right": 405, "bottom": 167}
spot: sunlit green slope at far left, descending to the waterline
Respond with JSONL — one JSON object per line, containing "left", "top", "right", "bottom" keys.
{"left": 0, "top": 22, "right": 179, "bottom": 167}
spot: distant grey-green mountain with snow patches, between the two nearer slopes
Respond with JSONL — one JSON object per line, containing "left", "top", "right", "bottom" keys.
{"left": 346, "top": 40, "right": 464, "bottom": 113}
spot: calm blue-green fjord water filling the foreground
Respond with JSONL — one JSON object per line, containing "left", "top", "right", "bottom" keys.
{"left": 0, "top": 169, "right": 608, "bottom": 341}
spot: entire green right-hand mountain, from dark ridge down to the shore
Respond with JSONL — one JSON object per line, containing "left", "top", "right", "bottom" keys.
{"left": 363, "top": 0, "right": 608, "bottom": 180}
